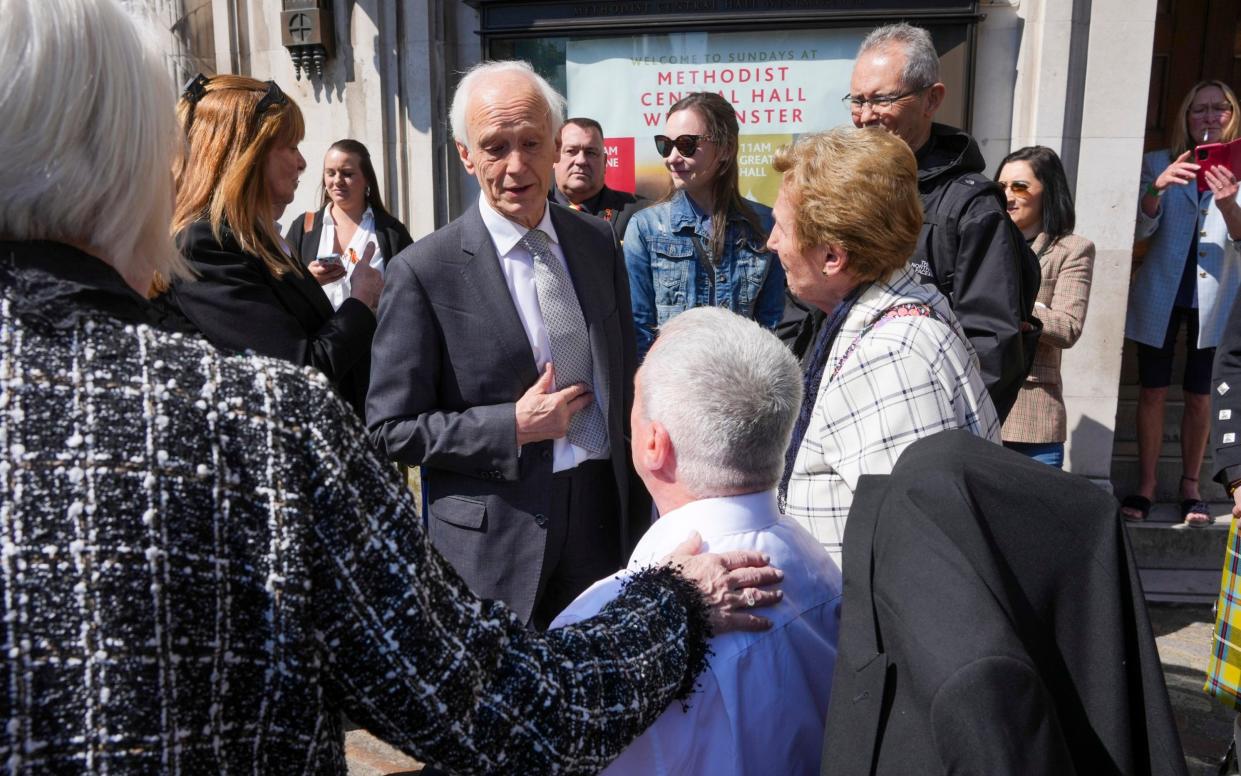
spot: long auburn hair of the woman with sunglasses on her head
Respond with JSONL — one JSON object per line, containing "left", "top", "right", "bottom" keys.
{"left": 172, "top": 76, "right": 305, "bottom": 277}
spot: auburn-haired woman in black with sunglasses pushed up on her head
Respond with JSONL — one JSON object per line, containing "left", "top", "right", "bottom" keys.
{"left": 169, "top": 76, "right": 383, "bottom": 416}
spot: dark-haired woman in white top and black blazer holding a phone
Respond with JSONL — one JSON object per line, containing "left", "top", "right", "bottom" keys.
{"left": 285, "top": 139, "right": 413, "bottom": 307}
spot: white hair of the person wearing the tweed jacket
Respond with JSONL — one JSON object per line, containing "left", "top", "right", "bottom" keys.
{"left": 0, "top": 0, "right": 189, "bottom": 277}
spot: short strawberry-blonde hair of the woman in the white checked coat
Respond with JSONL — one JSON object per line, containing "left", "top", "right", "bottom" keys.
{"left": 772, "top": 127, "right": 922, "bottom": 283}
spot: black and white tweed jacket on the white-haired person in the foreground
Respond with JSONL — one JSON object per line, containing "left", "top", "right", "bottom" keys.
{"left": 0, "top": 242, "right": 709, "bottom": 774}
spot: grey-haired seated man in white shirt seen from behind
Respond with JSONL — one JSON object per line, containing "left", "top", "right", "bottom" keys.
{"left": 552, "top": 307, "right": 841, "bottom": 776}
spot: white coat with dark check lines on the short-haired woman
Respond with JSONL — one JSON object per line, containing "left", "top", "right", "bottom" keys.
{"left": 786, "top": 268, "right": 1000, "bottom": 564}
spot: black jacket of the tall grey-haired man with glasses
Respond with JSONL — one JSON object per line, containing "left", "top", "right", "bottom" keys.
{"left": 910, "top": 124, "right": 1040, "bottom": 420}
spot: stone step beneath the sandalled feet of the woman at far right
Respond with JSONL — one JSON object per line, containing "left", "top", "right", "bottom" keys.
{"left": 1126, "top": 503, "right": 1232, "bottom": 603}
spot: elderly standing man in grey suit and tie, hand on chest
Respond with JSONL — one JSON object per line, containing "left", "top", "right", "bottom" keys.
{"left": 366, "top": 62, "right": 649, "bottom": 627}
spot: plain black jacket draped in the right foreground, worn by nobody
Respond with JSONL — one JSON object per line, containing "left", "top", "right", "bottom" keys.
{"left": 823, "top": 431, "right": 1185, "bottom": 776}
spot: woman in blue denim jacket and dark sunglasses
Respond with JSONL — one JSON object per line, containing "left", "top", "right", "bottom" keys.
{"left": 623, "top": 92, "right": 784, "bottom": 359}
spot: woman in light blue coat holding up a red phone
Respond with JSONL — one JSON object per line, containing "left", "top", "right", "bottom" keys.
{"left": 1121, "top": 81, "right": 1241, "bottom": 525}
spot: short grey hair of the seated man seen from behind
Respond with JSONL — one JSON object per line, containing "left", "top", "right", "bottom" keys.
{"left": 634, "top": 307, "right": 802, "bottom": 498}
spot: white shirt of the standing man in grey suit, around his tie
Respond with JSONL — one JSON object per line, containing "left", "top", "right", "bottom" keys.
{"left": 478, "top": 194, "right": 612, "bottom": 472}
